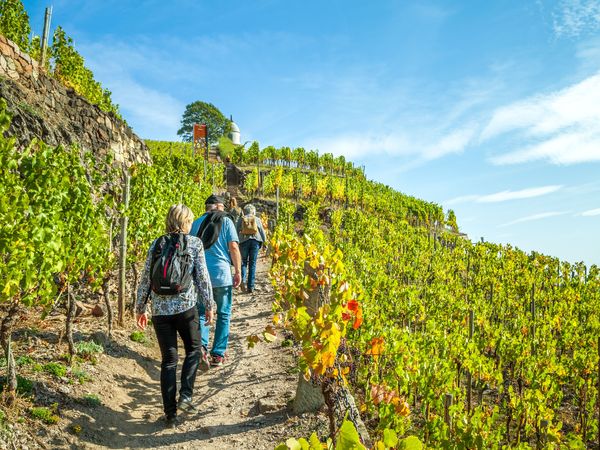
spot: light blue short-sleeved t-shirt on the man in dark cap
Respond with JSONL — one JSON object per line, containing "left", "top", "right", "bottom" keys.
{"left": 190, "top": 213, "right": 239, "bottom": 287}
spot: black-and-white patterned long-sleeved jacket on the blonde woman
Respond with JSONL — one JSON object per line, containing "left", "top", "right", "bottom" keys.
{"left": 135, "top": 236, "right": 214, "bottom": 316}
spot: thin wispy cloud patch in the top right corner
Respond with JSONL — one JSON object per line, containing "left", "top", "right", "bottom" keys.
{"left": 554, "top": 0, "right": 600, "bottom": 37}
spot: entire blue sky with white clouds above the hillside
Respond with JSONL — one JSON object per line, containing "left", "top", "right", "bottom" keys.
{"left": 24, "top": 0, "right": 600, "bottom": 264}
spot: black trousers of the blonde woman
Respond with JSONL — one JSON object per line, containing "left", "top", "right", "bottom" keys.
{"left": 152, "top": 306, "right": 200, "bottom": 417}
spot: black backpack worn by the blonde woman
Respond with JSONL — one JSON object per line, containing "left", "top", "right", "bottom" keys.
{"left": 150, "top": 233, "right": 194, "bottom": 295}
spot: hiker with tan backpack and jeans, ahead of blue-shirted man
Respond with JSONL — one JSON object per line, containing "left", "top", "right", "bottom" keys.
{"left": 237, "top": 204, "right": 267, "bottom": 294}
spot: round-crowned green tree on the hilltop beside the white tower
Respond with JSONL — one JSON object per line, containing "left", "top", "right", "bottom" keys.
{"left": 177, "top": 100, "right": 231, "bottom": 144}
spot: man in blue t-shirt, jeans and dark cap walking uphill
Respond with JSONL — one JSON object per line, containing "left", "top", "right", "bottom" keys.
{"left": 190, "top": 195, "right": 241, "bottom": 369}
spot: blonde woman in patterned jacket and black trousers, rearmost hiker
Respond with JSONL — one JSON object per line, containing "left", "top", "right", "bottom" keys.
{"left": 135, "top": 204, "right": 214, "bottom": 426}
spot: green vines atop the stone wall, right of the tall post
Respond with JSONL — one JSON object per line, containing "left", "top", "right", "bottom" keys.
{"left": 50, "top": 27, "right": 120, "bottom": 118}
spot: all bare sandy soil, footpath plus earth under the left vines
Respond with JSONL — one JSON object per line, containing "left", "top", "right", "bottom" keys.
{"left": 0, "top": 255, "right": 327, "bottom": 449}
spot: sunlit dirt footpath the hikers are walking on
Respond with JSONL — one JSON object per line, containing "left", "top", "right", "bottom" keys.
{"left": 54, "top": 260, "right": 319, "bottom": 449}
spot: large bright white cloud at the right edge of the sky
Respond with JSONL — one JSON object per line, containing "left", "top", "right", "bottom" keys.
{"left": 481, "top": 73, "right": 600, "bottom": 165}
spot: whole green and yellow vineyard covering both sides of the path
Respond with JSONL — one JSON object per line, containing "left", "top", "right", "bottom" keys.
{"left": 0, "top": 2, "right": 600, "bottom": 450}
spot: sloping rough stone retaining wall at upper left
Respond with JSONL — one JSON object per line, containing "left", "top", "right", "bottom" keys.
{"left": 0, "top": 35, "right": 151, "bottom": 166}
